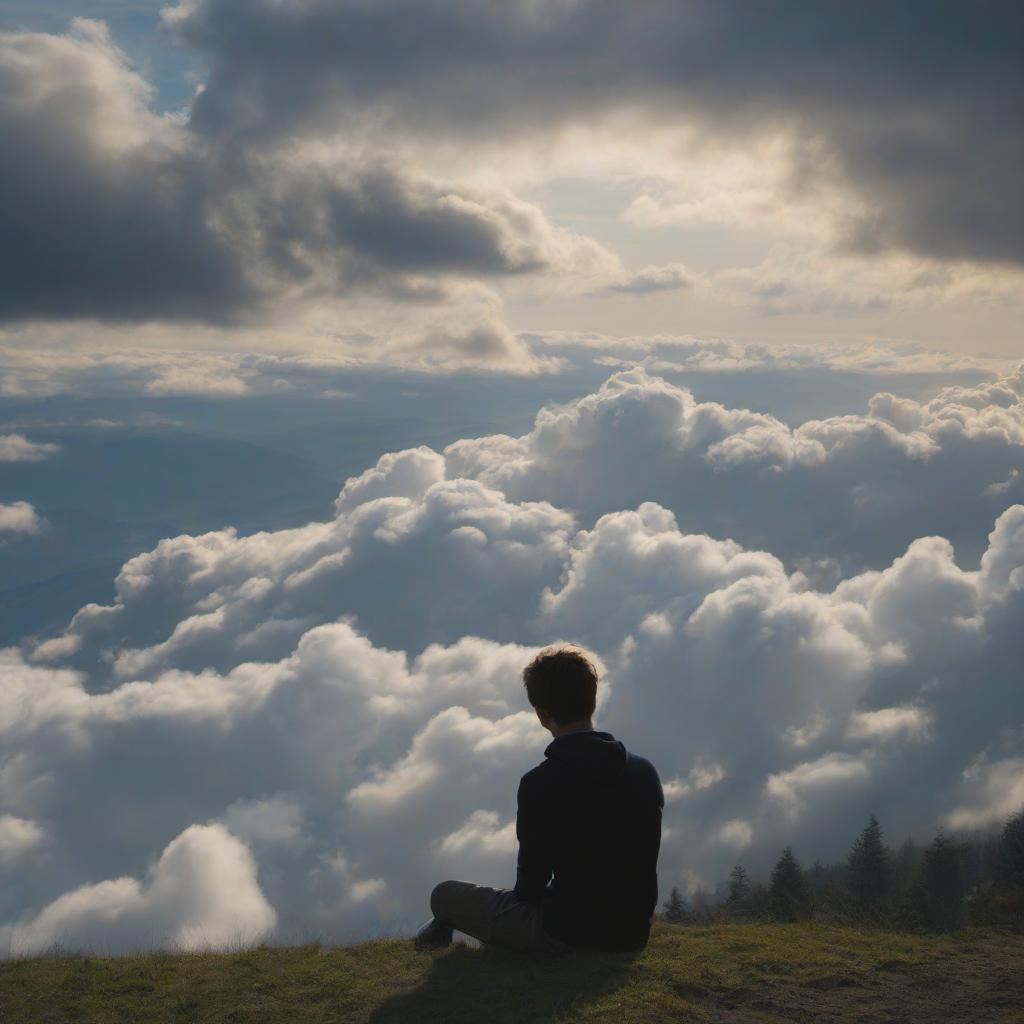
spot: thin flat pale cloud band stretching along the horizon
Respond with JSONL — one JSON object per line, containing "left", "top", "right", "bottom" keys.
{"left": 0, "top": 333, "right": 1015, "bottom": 401}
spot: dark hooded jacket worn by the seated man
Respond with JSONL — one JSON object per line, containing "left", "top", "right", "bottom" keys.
{"left": 515, "top": 730, "right": 665, "bottom": 949}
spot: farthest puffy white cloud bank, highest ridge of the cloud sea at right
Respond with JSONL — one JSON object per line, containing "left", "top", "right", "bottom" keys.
{"left": 444, "top": 369, "right": 1024, "bottom": 570}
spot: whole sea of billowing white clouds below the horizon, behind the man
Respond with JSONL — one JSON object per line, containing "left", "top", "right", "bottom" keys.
{"left": 0, "top": 367, "right": 1024, "bottom": 954}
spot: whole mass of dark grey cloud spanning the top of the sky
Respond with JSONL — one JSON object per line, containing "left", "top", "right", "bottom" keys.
{"left": 0, "top": 0, "right": 1024, "bottom": 323}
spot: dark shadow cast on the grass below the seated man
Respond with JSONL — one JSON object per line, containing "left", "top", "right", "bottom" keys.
{"left": 370, "top": 944, "right": 639, "bottom": 1024}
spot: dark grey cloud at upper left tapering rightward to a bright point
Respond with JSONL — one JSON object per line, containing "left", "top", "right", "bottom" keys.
{"left": 0, "top": 22, "right": 611, "bottom": 323}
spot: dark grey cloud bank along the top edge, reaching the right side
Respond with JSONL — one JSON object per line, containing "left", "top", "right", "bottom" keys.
{"left": 169, "top": 0, "right": 1024, "bottom": 263}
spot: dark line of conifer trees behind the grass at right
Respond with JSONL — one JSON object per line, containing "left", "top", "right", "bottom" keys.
{"left": 658, "top": 808, "right": 1024, "bottom": 931}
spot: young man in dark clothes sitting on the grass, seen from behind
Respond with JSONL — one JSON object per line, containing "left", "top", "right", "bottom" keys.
{"left": 415, "top": 647, "right": 665, "bottom": 953}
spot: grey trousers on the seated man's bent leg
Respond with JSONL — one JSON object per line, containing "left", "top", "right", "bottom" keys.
{"left": 430, "top": 882, "right": 573, "bottom": 953}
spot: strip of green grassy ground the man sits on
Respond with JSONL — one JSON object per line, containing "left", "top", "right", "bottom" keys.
{"left": 0, "top": 924, "right": 1024, "bottom": 1024}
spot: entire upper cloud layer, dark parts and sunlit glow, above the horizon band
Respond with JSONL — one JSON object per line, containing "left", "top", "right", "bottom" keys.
{"left": 0, "top": 0, "right": 1024, "bottom": 368}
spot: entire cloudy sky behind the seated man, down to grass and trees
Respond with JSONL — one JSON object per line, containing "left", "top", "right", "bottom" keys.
{"left": 0, "top": 0, "right": 1024, "bottom": 953}
